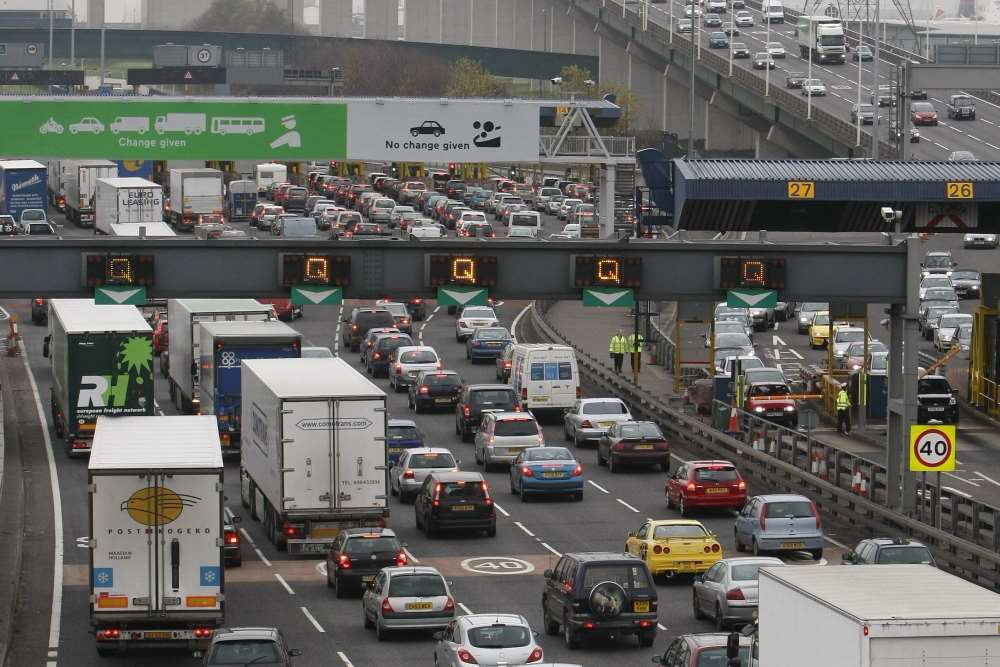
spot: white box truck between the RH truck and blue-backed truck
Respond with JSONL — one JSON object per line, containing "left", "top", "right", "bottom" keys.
{"left": 166, "top": 299, "right": 273, "bottom": 414}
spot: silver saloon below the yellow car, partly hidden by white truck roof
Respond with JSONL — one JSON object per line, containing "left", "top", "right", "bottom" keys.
{"left": 692, "top": 557, "right": 784, "bottom": 631}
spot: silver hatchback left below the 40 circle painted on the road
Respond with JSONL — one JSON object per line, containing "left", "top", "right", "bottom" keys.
{"left": 361, "top": 565, "right": 455, "bottom": 641}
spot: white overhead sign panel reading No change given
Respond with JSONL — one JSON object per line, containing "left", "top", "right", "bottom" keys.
{"left": 347, "top": 99, "right": 539, "bottom": 162}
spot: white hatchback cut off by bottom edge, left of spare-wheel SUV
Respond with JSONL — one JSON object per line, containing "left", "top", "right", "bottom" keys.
{"left": 434, "top": 614, "right": 543, "bottom": 667}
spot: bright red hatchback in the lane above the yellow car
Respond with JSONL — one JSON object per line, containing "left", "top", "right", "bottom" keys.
{"left": 666, "top": 461, "right": 747, "bottom": 516}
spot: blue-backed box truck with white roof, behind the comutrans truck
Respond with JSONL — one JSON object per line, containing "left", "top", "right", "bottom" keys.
{"left": 199, "top": 320, "right": 302, "bottom": 451}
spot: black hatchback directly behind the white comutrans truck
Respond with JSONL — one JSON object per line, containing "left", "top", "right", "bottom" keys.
{"left": 326, "top": 527, "right": 408, "bottom": 598}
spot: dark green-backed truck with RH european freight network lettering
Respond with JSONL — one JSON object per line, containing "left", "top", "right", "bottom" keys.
{"left": 42, "top": 299, "right": 153, "bottom": 456}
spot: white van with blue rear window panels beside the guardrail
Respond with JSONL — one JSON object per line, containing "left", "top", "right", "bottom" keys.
{"left": 510, "top": 343, "right": 581, "bottom": 412}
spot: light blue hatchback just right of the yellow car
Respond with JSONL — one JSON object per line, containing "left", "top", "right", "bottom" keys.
{"left": 733, "top": 494, "right": 824, "bottom": 560}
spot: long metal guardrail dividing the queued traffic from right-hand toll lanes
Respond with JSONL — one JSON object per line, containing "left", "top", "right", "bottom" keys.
{"left": 529, "top": 303, "right": 1000, "bottom": 590}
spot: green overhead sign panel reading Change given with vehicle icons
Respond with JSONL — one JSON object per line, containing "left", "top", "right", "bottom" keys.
{"left": 7, "top": 97, "right": 347, "bottom": 160}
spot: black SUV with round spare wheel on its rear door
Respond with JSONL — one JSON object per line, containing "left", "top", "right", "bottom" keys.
{"left": 542, "top": 552, "right": 657, "bottom": 649}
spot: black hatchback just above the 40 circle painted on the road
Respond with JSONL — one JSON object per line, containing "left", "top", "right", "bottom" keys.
{"left": 413, "top": 472, "right": 497, "bottom": 537}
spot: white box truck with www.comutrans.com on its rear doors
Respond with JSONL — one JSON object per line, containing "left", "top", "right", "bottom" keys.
{"left": 240, "top": 358, "right": 389, "bottom": 555}
